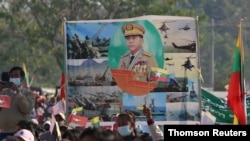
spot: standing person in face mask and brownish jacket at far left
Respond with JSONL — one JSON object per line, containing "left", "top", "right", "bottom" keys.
{"left": 0, "top": 66, "right": 36, "bottom": 140}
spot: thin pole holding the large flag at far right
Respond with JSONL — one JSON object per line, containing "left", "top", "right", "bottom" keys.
{"left": 240, "top": 19, "right": 247, "bottom": 124}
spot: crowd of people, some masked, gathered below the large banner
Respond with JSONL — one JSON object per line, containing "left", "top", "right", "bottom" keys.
{"left": 0, "top": 66, "right": 164, "bottom": 141}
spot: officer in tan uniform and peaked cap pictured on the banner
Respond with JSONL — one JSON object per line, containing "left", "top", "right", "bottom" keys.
{"left": 119, "top": 23, "right": 158, "bottom": 81}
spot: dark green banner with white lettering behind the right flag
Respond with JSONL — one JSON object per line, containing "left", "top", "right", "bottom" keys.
{"left": 201, "top": 89, "right": 250, "bottom": 124}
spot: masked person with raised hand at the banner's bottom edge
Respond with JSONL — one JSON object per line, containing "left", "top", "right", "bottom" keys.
{"left": 116, "top": 105, "right": 164, "bottom": 141}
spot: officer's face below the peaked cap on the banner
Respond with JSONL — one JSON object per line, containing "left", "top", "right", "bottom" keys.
{"left": 125, "top": 35, "right": 143, "bottom": 53}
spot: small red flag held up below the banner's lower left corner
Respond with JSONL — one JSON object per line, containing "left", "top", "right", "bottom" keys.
{"left": 68, "top": 114, "right": 88, "bottom": 127}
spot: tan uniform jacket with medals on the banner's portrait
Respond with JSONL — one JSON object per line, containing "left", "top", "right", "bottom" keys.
{"left": 119, "top": 50, "right": 158, "bottom": 81}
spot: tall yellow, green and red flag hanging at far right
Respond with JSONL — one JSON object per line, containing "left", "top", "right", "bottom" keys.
{"left": 227, "top": 24, "right": 247, "bottom": 125}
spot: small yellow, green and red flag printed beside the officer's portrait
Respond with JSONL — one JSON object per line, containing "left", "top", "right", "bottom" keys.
{"left": 150, "top": 67, "right": 169, "bottom": 82}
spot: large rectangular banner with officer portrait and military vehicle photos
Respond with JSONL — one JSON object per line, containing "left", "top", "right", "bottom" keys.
{"left": 65, "top": 16, "right": 201, "bottom": 125}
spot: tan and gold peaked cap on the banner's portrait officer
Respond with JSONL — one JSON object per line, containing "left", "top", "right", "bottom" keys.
{"left": 122, "top": 23, "right": 145, "bottom": 37}
